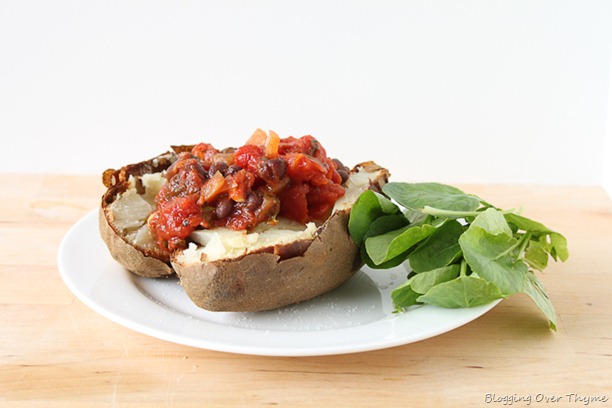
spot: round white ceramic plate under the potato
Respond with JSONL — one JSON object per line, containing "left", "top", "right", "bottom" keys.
{"left": 58, "top": 211, "right": 499, "bottom": 356}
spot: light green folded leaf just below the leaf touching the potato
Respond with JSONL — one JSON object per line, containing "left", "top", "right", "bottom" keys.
{"left": 365, "top": 224, "right": 436, "bottom": 265}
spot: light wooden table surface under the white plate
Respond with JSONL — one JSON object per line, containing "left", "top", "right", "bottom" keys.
{"left": 0, "top": 174, "right": 612, "bottom": 407}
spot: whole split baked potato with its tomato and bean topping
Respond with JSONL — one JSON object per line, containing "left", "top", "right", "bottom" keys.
{"left": 100, "top": 131, "right": 389, "bottom": 312}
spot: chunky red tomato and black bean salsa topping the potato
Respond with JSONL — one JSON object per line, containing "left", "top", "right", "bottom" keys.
{"left": 148, "top": 130, "right": 349, "bottom": 251}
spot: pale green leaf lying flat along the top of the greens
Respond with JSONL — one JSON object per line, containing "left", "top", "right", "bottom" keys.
{"left": 383, "top": 183, "right": 480, "bottom": 211}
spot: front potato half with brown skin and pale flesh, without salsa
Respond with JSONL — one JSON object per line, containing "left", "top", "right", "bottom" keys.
{"left": 171, "top": 162, "right": 389, "bottom": 312}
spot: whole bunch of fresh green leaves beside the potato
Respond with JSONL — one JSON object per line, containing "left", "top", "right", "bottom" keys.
{"left": 349, "top": 182, "right": 569, "bottom": 330}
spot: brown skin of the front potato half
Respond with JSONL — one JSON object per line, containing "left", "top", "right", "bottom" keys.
{"left": 171, "top": 163, "right": 389, "bottom": 312}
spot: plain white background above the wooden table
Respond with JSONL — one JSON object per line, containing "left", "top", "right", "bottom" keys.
{"left": 0, "top": 0, "right": 612, "bottom": 191}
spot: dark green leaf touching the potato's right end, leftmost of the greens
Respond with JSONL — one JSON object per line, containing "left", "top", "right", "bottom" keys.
{"left": 348, "top": 190, "right": 400, "bottom": 245}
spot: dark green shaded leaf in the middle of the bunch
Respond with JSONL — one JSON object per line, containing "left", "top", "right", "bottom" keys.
{"left": 408, "top": 220, "right": 465, "bottom": 272}
